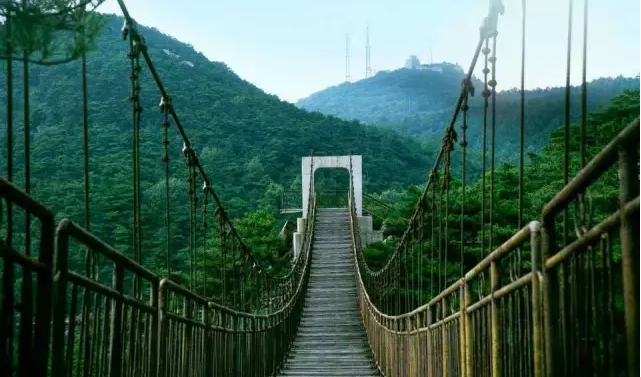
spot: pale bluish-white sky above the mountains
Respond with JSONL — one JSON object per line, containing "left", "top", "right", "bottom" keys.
{"left": 99, "top": 0, "right": 640, "bottom": 102}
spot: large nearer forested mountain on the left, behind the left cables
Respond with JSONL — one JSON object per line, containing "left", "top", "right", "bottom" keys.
{"left": 0, "top": 15, "right": 433, "bottom": 274}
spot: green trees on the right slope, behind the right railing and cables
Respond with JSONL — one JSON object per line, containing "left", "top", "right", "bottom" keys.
{"left": 366, "top": 89, "right": 640, "bottom": 302}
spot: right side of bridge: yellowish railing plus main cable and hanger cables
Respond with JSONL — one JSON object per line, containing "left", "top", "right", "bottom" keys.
{"left": 350, "top": 1, "right": 639, "bottom": 377}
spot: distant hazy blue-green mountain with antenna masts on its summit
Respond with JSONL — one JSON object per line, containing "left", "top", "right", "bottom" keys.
{"left": 297, "top": 69, "right": 639, "bottom": 161}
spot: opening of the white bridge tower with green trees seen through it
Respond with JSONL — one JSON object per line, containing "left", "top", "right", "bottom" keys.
{"left": 314, "top": 168, "right": 349, "bottom": 208}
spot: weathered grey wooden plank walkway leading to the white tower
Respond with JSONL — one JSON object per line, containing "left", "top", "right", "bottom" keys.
{"left": 281, "top": 209, "right": 379, "bottom": 377}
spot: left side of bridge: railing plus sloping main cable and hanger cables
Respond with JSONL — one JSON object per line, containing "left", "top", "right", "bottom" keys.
{"left": 0, "top": 1, "right": 316, "bottom": 377}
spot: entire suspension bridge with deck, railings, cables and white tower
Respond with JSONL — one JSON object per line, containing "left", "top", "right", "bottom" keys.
{"left": 0, "top": 1, "right": 639, "bottom": 377}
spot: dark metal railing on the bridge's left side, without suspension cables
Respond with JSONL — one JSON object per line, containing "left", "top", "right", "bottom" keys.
{"left": 0, "top": 157, "right": 316, "bottom": 377}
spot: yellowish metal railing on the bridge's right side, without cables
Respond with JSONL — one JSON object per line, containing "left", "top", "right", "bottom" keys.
{"left": 350, "top": 83, "right": 639, "bottom": 377}
